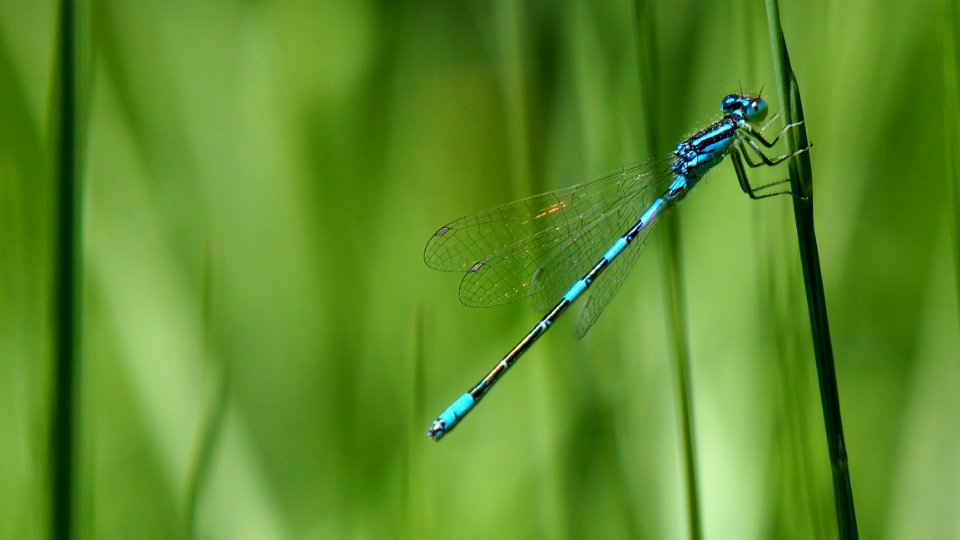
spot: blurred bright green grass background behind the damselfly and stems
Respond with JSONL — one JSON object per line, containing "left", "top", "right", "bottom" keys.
{"left": 0, "top": 0, "right": 960, "bottom": 538}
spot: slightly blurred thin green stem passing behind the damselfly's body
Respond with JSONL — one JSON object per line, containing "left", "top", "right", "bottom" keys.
{"left": 634, "top": 0, "right": 703, "bottom": 540}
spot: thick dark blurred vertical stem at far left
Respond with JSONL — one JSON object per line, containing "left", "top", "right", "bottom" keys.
{"left": 49, "top": 0, "right": 81, "bottom": 540}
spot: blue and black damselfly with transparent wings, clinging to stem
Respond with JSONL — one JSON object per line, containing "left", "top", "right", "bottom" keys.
{"left": 423, "top": 94, "right": 809, "bottom": 440}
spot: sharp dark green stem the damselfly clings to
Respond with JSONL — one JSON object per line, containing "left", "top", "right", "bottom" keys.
{"left": 767, "top": 0, "right": 858, "bottom": 539}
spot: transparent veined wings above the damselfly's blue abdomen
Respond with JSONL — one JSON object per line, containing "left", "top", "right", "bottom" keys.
{"left": 424, "top": 160, "right": 668, "bottom": 306}
